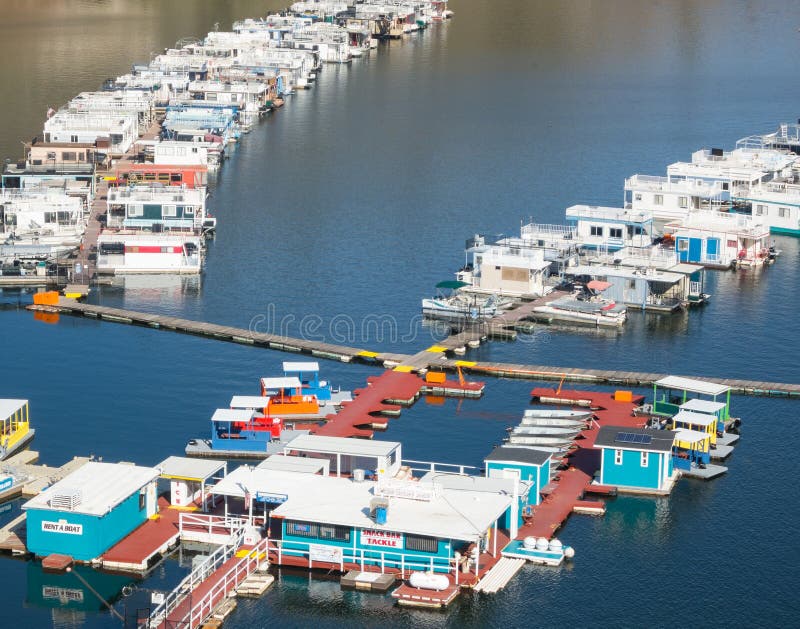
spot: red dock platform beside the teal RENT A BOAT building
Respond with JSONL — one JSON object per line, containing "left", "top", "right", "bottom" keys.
{"left": 101, "top": 496, "right": 181, "bottom": 572}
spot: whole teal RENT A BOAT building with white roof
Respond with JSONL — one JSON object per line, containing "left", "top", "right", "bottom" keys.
{"left": 22, "top": 461, "right": 159, "bottom": 562}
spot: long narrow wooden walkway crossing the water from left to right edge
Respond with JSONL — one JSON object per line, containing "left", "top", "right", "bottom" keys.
{"left": 28, "top": 298, "right": 800, "bottom": 399}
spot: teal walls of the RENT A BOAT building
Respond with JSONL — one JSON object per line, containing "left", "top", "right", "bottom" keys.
{"left": 27, "top": 491, "right": 147, "bottom": 561}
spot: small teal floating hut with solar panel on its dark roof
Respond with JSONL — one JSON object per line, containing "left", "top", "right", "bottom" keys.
{"left": 594, "top": 426, "right": 677, "bottom": 494}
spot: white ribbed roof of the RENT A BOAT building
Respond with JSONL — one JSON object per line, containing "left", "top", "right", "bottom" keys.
{"left": 22, "top": 461, "right": 159, "bottom": 516}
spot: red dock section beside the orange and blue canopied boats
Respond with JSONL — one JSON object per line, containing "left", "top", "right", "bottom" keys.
{"left": 312, "top": 371, "right": 484, "bottom": 439}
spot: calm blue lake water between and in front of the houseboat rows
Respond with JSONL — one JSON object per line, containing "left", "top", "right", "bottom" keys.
{"left": 0, "top": 0, "right": 800, "bottom": 627}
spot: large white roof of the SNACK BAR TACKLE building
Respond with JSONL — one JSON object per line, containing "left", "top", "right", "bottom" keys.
{"left": 211, "top": 466, "right": 511, "bottom": 541}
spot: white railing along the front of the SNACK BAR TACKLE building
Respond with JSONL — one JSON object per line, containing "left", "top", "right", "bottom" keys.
{"left": 268, "top": 540, "right": 463, "bottom": 584}
